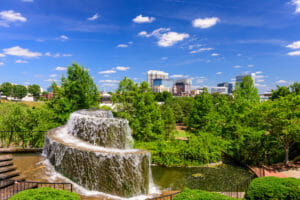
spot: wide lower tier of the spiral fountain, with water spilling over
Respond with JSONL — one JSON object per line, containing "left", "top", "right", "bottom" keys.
{"left": 43, "top": 110, "right": 150, "bottom": 197}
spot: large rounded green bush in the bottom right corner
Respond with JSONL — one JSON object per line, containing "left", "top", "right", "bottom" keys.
{"left": 245, "top": 176, "right": 300, "bottom": 200}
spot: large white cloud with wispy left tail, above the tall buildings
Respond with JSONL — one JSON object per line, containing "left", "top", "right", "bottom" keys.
{"left": 138, "top": 28, "right": 190, "bottom": 47}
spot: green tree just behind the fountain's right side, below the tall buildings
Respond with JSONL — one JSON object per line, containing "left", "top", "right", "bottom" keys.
{"left": 112, "top": 77, "right": 164, "bottom": 141}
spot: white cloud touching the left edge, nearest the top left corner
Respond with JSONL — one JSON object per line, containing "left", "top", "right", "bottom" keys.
{"left": 0, "top": 10, "right": 27, "bottom": 27}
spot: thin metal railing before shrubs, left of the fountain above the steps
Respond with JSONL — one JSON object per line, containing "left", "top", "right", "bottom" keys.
{"left": 0, "top": 131, "right": 46, "bottom": 148}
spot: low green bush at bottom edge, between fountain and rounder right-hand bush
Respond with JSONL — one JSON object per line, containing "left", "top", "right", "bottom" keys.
{"left": 174, "top": 189, "right": 234, "bottom": 200}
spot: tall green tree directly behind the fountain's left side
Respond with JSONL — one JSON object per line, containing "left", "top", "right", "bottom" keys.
{"left": 47, "top": 63, "right": 100, "bottom": 124}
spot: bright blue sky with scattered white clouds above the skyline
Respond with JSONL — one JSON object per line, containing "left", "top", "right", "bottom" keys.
{"left": 0, "top": 0, "right": 300, "bottom": 92}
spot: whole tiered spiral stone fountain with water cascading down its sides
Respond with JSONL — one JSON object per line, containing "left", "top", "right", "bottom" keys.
{"left": 43, "top": 110, "right": 151, "bottom": 197}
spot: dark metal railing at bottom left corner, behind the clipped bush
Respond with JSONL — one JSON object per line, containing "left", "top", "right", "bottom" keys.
{"left": 0, "top": 180, "right": 73, "bottom": 200}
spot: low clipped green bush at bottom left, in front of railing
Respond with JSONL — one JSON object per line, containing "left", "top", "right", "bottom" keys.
{"left": 9, "top": 188, "right": 80, "bottom": 200}
